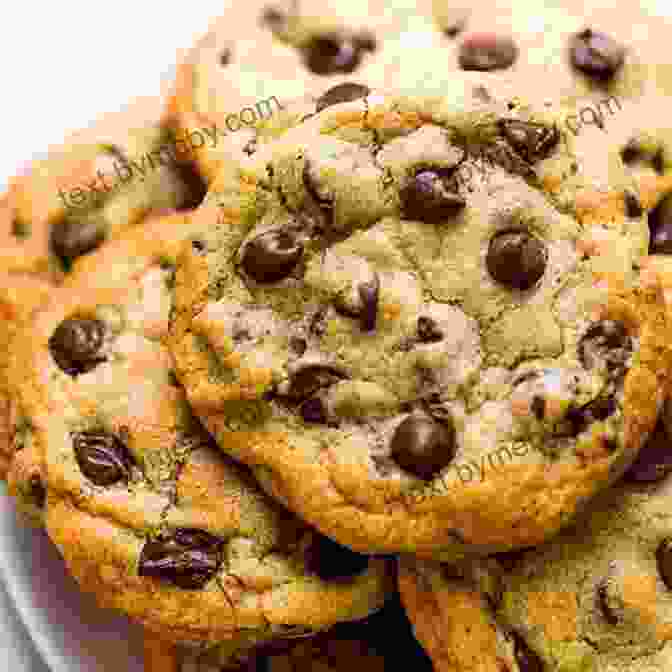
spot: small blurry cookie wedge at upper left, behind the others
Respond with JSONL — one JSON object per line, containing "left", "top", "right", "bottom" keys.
{"left": 0, "top": 97, "right": 204, "bottom": 277}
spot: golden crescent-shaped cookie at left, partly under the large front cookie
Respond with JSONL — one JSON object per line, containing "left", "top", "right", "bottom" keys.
{"left": 8, "top": 213, "right": 390, "bottom": 645}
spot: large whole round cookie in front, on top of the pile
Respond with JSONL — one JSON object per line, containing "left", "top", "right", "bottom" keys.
{"left": 171, "top": 84, "right": 671, "bottom": 559}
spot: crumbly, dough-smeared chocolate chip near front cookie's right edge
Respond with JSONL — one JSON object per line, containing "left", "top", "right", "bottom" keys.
{"left": 577, "top": 320, "right": 632, "bottom": 378}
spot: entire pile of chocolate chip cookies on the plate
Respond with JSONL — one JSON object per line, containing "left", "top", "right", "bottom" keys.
{"left": 0, "top": 0, "right": 672, "bottom": 672}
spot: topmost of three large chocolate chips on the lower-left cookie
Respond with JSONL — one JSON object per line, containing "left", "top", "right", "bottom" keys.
{"left": 49, "top": 318, "right": 106, "bottom": 377}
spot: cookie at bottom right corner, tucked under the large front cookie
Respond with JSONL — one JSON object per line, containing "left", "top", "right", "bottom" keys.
{"left": 400, "top": 460, "right": 672, "bottom": 672}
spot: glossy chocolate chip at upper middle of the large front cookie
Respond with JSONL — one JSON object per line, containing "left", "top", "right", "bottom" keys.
{"left": 399, "top": 168, "right": 466, "bottom": 224}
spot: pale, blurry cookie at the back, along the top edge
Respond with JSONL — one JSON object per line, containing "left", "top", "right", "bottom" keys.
{"left": 171, "top": 0, "right": 672, "bottom": 180}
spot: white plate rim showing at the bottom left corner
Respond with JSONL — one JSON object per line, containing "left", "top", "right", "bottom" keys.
{"left": 0, "top": 484, "right": 143, "bottom": 672}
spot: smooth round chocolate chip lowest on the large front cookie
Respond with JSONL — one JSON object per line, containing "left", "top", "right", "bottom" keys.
{"left": 390, "top": 414, "right": 456, "bottom": 481}
